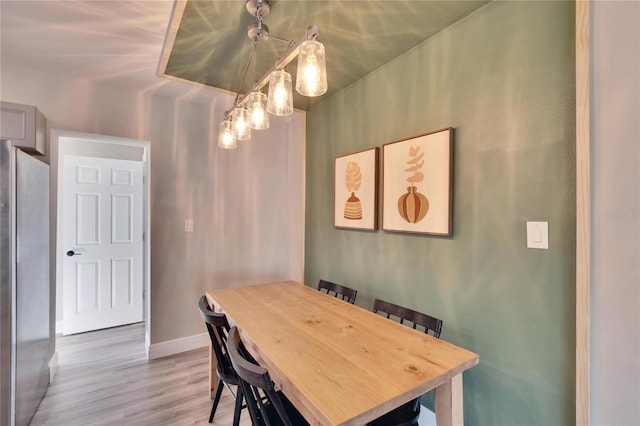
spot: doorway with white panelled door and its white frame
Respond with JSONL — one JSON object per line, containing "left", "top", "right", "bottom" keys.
{"left": 51, "top": 129, "right": 151, "bottom": 359}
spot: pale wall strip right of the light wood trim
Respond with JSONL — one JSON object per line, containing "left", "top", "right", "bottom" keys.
{"left": 591, "top": 1, "right": 640, "bottom": 425}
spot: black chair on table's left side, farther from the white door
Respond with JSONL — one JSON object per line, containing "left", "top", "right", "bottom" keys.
{"left": 227, "top": 326, "right": 309, "bottom": 426}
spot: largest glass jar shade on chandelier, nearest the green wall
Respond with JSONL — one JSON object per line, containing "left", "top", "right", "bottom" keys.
{"left": 296, "top": 40, "right": 327, "bottom": 96}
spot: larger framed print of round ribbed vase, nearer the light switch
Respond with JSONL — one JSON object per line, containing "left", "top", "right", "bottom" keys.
{"left": 382, "top": 127, "right": 453, "bottom": 236}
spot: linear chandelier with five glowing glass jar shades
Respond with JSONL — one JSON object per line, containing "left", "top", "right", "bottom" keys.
{"left": 218, "top": 0, "right": 327, "bottom": 149}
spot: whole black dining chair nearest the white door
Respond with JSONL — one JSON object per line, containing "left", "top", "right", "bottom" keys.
{"left": 198, "top": 296, "right": 243, "bottom": 426}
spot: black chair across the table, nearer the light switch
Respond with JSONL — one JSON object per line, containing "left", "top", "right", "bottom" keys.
{"left": 369, "top": 299, "right": 442, "bottom": 426}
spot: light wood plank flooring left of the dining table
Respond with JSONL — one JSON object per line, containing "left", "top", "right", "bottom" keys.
{"left": 31, "top": 323, "right": 251, "bottom": 426}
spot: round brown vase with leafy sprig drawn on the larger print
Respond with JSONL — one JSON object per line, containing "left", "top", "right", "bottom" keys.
{"left": 398, "top": 146, "right": 429, "bottom": 223}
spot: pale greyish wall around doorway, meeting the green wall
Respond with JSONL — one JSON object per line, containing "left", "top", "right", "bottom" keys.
{"left": 0, "top": 57, "right": 305, "bottom": 344}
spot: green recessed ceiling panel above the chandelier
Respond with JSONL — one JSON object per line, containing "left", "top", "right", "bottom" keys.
{"left": 158, "top": 0, "right": 488, "bottom": 110}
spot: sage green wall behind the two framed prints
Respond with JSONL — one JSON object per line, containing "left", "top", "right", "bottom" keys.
{"left": 305, "top": 1, "right": 575, "bottom": 425}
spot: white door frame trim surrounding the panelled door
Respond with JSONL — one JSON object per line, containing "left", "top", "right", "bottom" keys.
{"left": 50, "top": 129, "right": 151, "bottom": 359}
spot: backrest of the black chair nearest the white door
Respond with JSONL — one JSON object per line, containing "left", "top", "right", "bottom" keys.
{"left": 198, "top": 296, "right": 238, "bottom": 384}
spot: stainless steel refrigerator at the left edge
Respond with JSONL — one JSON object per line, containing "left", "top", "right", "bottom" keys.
{"left": 0, "top": 140, "right": 50, "bottom": 425}
